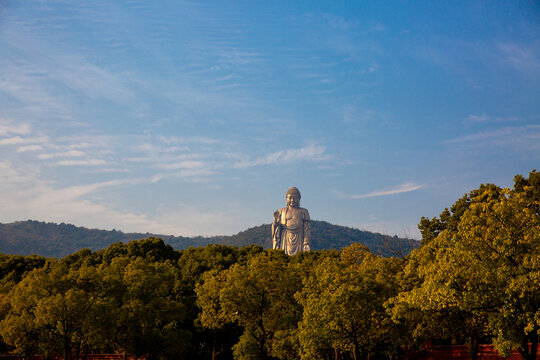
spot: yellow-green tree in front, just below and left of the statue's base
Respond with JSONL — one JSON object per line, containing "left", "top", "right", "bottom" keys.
{"left": 196, "top": 250, "right": 301, "bottom": 359}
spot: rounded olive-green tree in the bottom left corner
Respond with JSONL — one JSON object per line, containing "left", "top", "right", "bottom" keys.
{"left": 0, "top": 261, "right": 110, "bottom": 359}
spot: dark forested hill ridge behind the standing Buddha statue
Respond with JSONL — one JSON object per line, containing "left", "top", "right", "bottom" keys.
{"left": 0, "top": 220, "right": 418, "bottom": 257}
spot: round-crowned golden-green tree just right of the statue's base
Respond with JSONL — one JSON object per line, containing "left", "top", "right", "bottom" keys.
{"left": 297, "top": 244, "right": 400, "bottom": 360}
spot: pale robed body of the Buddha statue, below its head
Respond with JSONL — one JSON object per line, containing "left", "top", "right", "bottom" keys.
{"left": 272, "top": 207, "right": 311, "bottom": 255}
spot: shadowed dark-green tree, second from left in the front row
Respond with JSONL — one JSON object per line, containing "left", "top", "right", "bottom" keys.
{"left": 103, "top": 257, "right": 191, "bottom": 359}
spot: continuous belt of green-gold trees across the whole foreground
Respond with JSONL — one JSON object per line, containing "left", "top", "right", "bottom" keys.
{"left": 0, "top": 171, "right": 540, "bottom": 360}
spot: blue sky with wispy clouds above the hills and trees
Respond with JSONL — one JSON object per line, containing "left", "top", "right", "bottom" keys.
{"left": 0, "top": 0, "right": 540, "bottom": 238}
